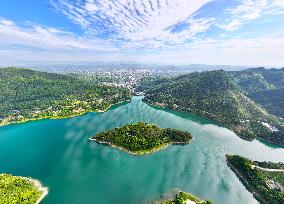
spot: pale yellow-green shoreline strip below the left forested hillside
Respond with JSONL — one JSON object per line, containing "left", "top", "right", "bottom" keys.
{"left": 0, "top": 99, "right": 131, "bottom": 127}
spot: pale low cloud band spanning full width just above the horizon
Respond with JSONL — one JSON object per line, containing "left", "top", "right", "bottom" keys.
{"left": 0, "top": 25, "right": 284, "bottom": 66}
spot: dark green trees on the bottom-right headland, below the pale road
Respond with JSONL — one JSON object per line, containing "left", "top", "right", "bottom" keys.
{"left": 226, "top": 155, "right": 284, "bottom": 204}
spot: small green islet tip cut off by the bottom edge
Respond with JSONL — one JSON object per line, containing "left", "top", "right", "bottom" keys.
{"left": 154, "top": 191, "right": 213, "bottom": 204}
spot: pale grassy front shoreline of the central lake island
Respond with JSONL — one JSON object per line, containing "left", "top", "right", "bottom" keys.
{"left": 89, "top": 137, "right": 192, "bottom": 156}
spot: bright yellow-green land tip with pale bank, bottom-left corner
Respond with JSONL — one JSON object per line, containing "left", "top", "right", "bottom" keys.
{"left": 0, "top": 174, "right": 48, "bottom": 204}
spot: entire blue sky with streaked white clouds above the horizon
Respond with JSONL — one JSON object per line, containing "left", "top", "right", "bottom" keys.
{"left": 0, "top": 0, "right": 284, "bottom": 67}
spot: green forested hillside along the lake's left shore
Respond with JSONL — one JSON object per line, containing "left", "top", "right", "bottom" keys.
{"left": 0, "top": 68, "right": 131, "bottom": 126}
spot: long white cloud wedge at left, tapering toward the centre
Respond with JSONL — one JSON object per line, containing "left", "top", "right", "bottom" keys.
{"left": 0, "top": 19, "right": 117, "bottom": 51}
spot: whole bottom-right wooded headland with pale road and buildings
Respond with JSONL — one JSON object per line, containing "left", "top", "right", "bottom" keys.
{"left": 226, "top": 155, "right": 284, "bottom": 204}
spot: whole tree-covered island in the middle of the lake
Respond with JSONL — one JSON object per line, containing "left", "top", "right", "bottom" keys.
{"left": 90, "top": 122, "right": 192, "bottom": 155}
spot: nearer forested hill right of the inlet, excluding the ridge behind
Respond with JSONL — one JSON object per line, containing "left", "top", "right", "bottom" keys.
{"left": 139, "top": 70, "right": 284, "bottom": 145}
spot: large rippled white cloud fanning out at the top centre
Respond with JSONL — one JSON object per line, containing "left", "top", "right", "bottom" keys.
{"left": 52, "top": 0, "right": 211, "bottom": 41}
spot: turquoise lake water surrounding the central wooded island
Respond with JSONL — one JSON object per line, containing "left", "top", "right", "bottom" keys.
{"left": 0, "top": 97, "right": 284, "bottom": 204}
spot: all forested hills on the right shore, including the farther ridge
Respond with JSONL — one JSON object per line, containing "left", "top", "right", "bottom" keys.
{"left": 137, "top": 68, "right": 284, "bottom": 146}
